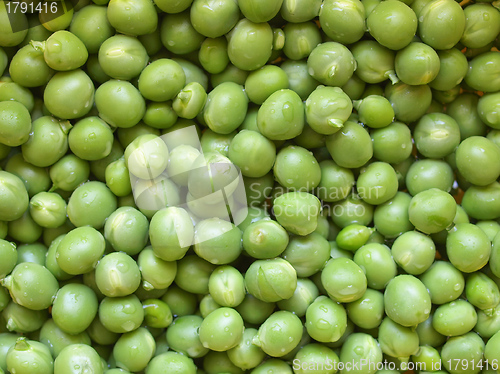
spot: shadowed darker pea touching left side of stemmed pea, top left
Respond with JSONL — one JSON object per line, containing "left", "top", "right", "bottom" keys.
{"left": 9, "top": 45, "right": 53, "bottom": 87}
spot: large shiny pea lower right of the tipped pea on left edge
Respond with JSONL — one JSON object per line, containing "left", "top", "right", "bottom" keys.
{"left": 52, "top": 283, "right": 98, "bottom": 335}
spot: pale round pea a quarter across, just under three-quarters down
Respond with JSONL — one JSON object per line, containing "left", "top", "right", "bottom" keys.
{"left": 95, "top": 252, "right": 141, "bottom": 297}
